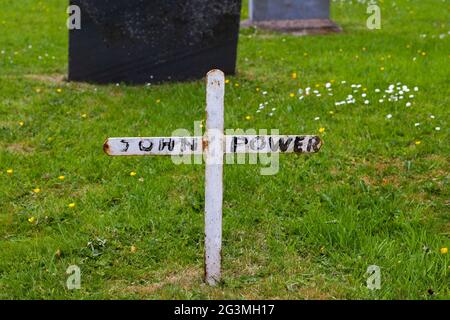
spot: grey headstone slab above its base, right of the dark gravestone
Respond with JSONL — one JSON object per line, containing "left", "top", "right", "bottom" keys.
{"left": 249, "top": 0, "right": 330, "bottom": 21}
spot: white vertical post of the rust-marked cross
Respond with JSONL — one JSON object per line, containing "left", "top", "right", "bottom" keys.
{"left": 203, "top": 70, "right": 225, "bottom": 286}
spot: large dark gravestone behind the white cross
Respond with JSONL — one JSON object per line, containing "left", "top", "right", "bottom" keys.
{"left": 69, "top": 0, "right": 241, "bottom": 84}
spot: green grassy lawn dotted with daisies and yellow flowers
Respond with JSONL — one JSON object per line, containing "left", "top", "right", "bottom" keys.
{"left": 0, "top": 0, "right": 450, "bottom": 299}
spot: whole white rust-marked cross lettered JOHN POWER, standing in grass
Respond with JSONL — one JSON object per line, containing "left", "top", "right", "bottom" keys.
{"left": 103, "top": 70, "right": 322, "bottom": 285}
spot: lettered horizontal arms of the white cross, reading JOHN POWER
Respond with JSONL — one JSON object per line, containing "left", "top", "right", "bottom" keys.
{"left": 104, "top": 135, "right": 322, "bottom": 156}
